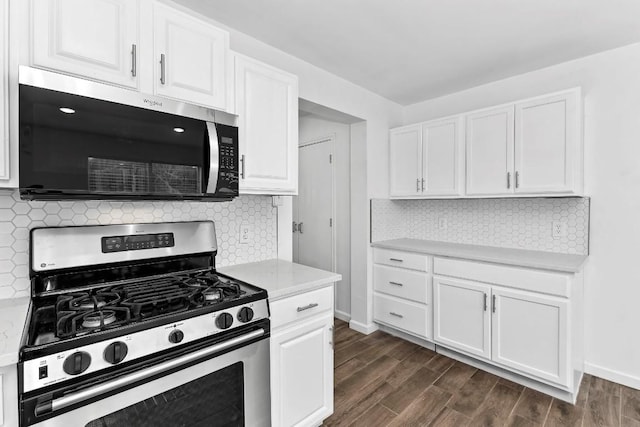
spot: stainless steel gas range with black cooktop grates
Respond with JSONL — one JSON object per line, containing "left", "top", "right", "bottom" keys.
{"left": 19, "top": 221, "right": 270, "bottom": 427}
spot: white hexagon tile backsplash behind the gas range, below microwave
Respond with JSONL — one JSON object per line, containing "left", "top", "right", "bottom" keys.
{"left": 0, "top": 191, "right": 277, "bottom": 299}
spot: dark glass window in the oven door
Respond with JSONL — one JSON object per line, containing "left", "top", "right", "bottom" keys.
{"left": 86, "top": 362, "right": 245, "bottom": 427}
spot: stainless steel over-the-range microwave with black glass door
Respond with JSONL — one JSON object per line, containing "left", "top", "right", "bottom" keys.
{"left": 19, "top": 67, "right": 239, "bottom": 200}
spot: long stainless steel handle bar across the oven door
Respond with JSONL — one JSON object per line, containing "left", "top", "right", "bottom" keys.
{"left": 35, "top": 329, "right": 266, "bottom": 417}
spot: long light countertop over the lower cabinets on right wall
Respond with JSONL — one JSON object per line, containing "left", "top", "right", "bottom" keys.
{"left": 371, "top": 239, "right": 587, "bottom": 273}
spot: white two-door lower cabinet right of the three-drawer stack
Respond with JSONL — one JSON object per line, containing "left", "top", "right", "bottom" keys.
{"left": 433, "top": 254, "right": 582, "bottom": 388}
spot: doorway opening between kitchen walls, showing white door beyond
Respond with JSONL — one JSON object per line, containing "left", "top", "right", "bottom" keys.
{"left": 292, "top": 99, "right": 362, "bottom": 321}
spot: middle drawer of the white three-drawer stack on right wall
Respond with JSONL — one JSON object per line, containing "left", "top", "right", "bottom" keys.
{"left": 373, "top": 265, "right": 430, "bottom": 304}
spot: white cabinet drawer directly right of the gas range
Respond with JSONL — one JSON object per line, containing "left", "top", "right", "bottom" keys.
{"left": 270, "top": 286, "right": 333, "bottom": 329}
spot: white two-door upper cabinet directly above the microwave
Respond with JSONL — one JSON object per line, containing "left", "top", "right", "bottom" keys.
{"left": 31, "top": 0, "right": 229, "bottom": 110}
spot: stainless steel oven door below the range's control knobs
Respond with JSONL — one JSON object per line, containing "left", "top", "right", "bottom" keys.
{"left": 21, "top": 329, "right": 271, "bottom": 427}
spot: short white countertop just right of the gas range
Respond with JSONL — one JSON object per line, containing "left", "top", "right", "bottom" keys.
{"left": 217, "top": 259, "right": 342, "bottom": 301}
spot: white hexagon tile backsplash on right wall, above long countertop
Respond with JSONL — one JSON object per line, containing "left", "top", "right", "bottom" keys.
{"left": 371, "top": 197, "right": 590, "bottom": 255}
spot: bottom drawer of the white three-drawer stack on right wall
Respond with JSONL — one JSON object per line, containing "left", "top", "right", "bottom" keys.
{"left": 373, "top": 294, "right": 431, "bottom": 339}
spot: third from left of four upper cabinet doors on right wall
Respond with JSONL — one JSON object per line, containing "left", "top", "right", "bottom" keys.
{"left": 466, "top": 106, "right": 513, "bottom": 196}
